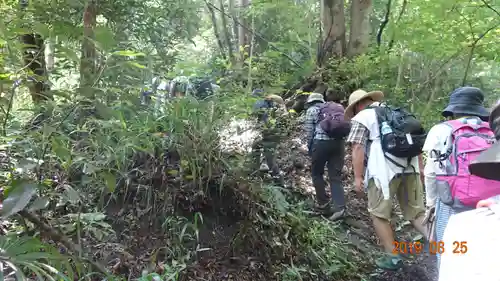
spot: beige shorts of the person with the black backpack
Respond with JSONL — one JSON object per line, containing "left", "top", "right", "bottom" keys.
{"left": 368, "top": 174, "right": 425, "bottom": 221}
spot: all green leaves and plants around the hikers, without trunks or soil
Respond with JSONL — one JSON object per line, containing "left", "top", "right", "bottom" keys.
{"left": 0, "top": 0, "right": 500, "bottom": 280}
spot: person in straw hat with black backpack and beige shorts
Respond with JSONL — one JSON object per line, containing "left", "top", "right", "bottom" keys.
{"left": 345, "top": 90, "right": 425, "bottom": 270}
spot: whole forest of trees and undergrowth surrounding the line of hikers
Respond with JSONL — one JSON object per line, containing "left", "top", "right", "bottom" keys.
{"left": 0, "top": 0, "right": 500, "bottom": 280}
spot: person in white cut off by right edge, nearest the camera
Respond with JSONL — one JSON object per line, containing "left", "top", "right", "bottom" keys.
{"left": 439, "top": 100, "right": 500, "bottom": 281}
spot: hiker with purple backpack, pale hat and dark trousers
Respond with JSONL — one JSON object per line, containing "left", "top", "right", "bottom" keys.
{"left": 304, "top": 93, "right": 350, "bottom": 220}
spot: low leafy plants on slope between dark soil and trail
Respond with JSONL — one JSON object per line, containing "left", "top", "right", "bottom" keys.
{"left": 257, "top": 186, "right": 361, "bottom": 280}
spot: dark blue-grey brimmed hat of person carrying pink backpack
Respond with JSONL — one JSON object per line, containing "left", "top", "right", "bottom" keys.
{"left": 441, "top": 87, "right": 490, "bottom": 119}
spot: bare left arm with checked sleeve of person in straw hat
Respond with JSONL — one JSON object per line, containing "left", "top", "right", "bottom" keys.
{"left": 346, "top": 121, "right": 369, "bottom": 182}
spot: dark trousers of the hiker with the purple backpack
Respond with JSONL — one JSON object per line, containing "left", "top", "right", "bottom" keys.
{"left": 311, "top": 139, "right": 345, "bottom": 208}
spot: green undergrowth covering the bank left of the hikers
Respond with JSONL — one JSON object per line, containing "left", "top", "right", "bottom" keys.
{"left": 0, "top": 90, "right": 368, "bottom": 280}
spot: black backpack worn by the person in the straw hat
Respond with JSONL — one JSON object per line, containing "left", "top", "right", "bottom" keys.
{"left": 374, "top": 105, "right": 427, "bottom": 162}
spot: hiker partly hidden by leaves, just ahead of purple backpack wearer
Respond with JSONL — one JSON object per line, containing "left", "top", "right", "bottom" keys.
{"left": 250, "top": 91, "right": 286, "bottom": 186}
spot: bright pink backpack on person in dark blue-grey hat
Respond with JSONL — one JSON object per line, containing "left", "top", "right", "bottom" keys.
{"left": 436, "top": 118, "right": 500, "bottom": 207}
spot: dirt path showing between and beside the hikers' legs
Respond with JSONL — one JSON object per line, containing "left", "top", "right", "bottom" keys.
{"left": 279, "top": 129, "right": 438, "bottom": 281}
